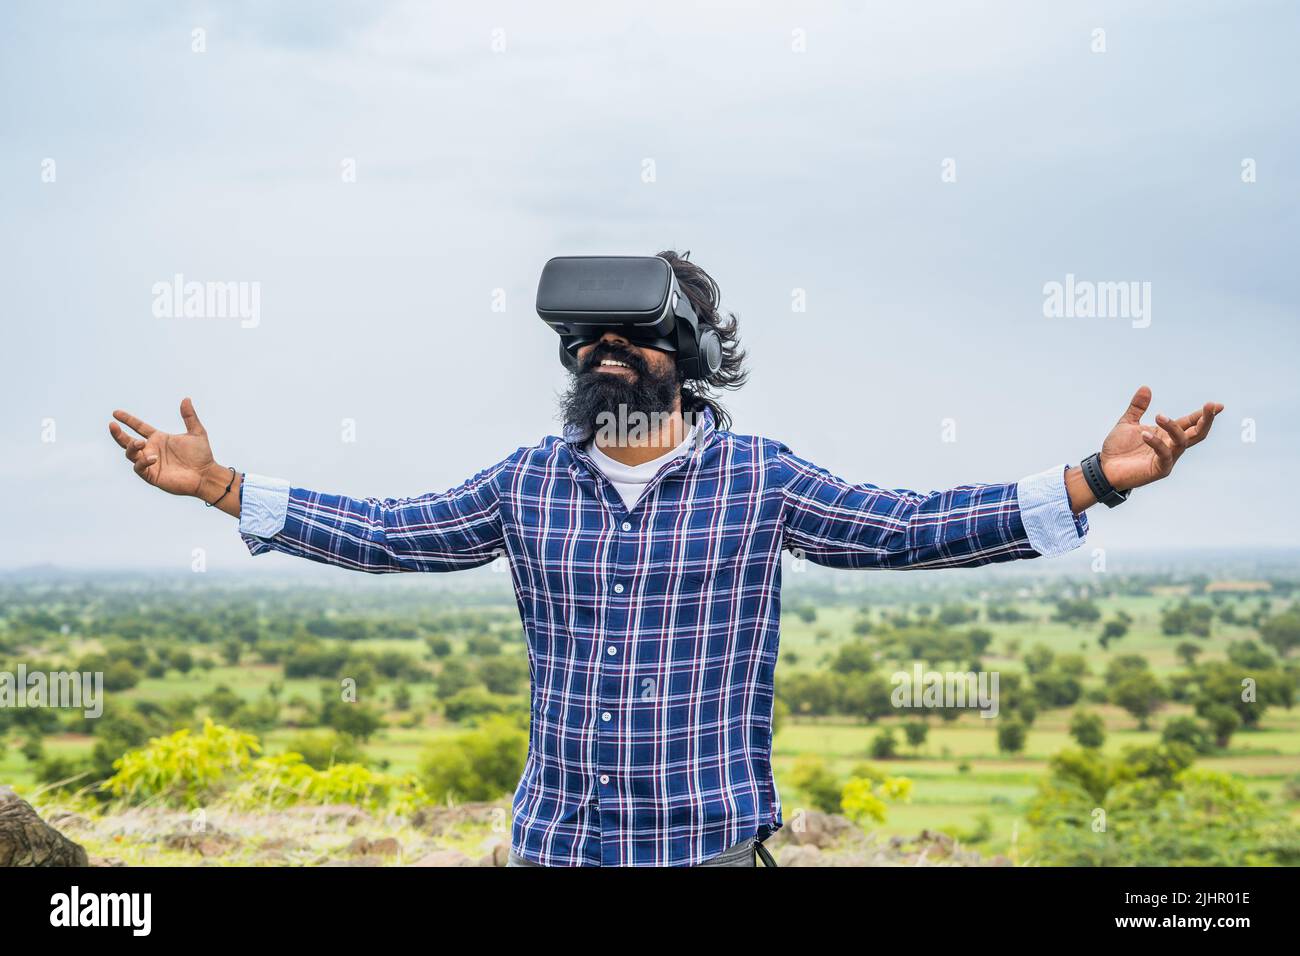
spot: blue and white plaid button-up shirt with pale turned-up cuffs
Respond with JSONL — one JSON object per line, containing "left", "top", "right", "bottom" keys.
{"left": 241, "top": 415, "right": 1087, "bottom": 866}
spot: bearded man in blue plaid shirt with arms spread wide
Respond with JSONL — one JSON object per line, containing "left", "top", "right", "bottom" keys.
{"left": 109, "top": 252, "right": 1223, "bottom": 866}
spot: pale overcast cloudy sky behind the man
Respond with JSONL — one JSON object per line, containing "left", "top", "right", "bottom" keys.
{"left": 0, "top": 0, "right": 1300, "bottom": 571}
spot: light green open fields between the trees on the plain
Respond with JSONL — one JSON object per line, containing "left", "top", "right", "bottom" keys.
{"left": 0, "top": 574, "right": 1300, "bottom": 862}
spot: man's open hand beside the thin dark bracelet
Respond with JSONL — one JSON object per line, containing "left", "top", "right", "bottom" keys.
{"left": 108, "top": 398, "right": 239, "bottom": 514}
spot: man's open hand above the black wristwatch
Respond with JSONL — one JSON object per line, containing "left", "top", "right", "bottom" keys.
{"left": 1101, "top": 385, "right": 1223, "bottom": 492}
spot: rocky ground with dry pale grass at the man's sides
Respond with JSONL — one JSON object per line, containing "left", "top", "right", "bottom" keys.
{"left": 0, "top": 788, "right": 1009, "bottom": 866}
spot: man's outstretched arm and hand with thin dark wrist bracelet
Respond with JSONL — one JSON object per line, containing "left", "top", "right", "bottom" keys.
{"left": 109, "top": 398, "right": 504, "bottom": 572}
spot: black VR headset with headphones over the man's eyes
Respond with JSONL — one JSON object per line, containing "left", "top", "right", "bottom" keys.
{"left": 537, "top": 256, "right": 723, "bottom": 378}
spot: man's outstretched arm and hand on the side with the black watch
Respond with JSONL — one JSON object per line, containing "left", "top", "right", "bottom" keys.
{"left": 781, "top": 386, "right": 1223, "bottom": 568}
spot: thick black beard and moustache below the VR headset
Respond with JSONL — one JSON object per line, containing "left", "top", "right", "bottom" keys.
{"left": 560, "top": 342, "right": 681, "bottom": 432}
